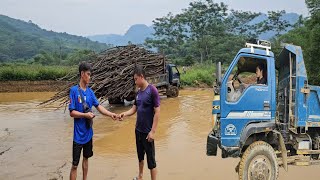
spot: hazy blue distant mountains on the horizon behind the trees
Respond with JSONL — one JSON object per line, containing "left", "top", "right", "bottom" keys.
{"left": 88, "top": 13, "right": 299, "bottom": 46}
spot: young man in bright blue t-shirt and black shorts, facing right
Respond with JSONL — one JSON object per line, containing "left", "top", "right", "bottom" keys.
{"left": 69, "top": 62, "right": 118, "bottom": 180}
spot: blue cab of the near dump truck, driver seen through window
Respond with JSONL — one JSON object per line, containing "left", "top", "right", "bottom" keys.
{"left": 212, "top": 40, "right": 276, "bottom": 158}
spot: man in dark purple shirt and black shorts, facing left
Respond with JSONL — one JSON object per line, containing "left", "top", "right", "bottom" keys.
{"left": 120, "top": 67, "right": 160, "bottom": 180}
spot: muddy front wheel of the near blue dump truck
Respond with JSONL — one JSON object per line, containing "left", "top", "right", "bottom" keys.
{"left": 239, "top": 141, "right": 279, "bottom": 180}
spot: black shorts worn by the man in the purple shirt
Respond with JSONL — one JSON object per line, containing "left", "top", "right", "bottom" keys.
{"left": 136, "top": 130, "right": 157, "bottom": 169}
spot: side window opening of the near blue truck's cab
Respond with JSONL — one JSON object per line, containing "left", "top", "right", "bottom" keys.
{"left": 227, "top": 57, "right": 268, "bottom": 102}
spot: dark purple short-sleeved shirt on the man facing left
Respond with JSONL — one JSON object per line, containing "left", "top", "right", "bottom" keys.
{"left": 134, "top": 84, "right": 160, "bottom": 133}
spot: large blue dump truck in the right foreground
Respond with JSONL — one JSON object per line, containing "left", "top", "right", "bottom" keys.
{"left": 206, "top": 40, "right": 320, "bottom": 180}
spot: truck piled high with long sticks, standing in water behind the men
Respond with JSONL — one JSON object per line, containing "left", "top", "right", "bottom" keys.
{"left": 42, "top": 45, "right": 180, "bottom": 106}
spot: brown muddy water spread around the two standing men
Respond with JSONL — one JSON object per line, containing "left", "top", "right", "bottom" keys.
{"left": 0, "top": 89, "right": 320, "bottom": 180}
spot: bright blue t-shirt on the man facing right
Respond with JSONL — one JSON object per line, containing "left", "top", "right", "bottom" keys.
{"left": 69, "top": 85, "right": 99, "bottom": 144}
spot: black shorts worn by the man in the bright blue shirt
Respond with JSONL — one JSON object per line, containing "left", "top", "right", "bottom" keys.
{"left": 72, "top": 139, "right": 93, "bottom": 166}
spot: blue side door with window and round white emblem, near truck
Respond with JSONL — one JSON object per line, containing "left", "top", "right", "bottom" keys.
{"left": 221, "top": 54, "right": 275, "bottom": 147}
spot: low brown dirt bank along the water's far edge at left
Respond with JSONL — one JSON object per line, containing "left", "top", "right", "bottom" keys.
{"left": 0, "top": 81, "right": 67, "bottom": 92}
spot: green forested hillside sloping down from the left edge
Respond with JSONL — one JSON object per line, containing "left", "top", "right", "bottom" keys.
{"left": 0, "top": 15, "right": 109, "bottom": 62}
